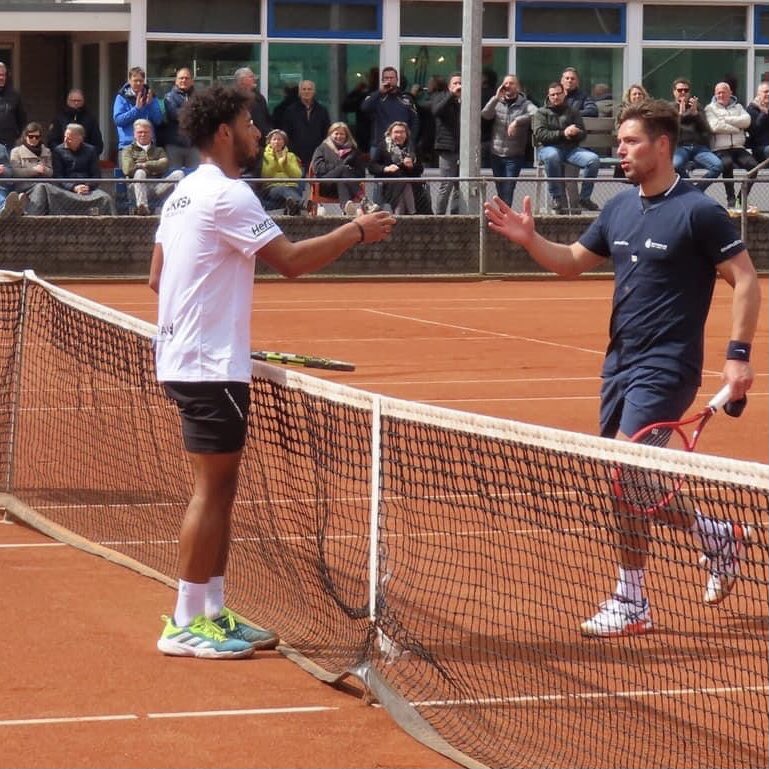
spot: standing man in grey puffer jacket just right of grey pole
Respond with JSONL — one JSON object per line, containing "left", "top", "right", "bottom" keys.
{"left": 481, "top": 75, "right": 537, "bottom": 206}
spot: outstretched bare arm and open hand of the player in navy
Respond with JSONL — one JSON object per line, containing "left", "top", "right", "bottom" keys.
{"left": 484, "top": 195, "right": 603, "bottom": 278}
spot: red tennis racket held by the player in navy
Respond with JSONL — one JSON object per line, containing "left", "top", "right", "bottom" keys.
{"left": 611, "top": 385, "right": 732, "bottom": 515}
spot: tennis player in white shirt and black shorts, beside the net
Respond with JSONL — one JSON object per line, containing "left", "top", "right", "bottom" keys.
{"left": 149, "top": 86, "right": 395, "bottom": 659}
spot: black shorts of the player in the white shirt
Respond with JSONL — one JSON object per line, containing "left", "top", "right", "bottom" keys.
{"left": 163, "top": 382, "right": 251, "bottom": 454}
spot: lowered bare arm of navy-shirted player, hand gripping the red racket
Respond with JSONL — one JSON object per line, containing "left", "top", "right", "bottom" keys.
{"left": 718, "top": 251, "right": 761, "bottom": 400}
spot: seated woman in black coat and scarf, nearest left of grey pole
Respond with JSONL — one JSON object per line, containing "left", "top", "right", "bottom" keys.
{"left": 369, "top": 120, "right": 426, "bottom": 214}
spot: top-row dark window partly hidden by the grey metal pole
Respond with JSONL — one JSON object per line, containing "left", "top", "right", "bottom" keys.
{"left": 400, "top": 0, "right": 508, "bottom": 39}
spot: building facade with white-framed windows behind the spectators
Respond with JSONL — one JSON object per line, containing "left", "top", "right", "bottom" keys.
{"left": 0, "top": 0, "right": 769, "bottom": 159}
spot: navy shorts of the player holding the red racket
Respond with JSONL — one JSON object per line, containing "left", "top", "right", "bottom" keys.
{"left": 601, "top": 368, "right": 699, "bottom": 438}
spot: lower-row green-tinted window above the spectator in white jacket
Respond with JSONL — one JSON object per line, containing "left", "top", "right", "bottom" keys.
{"left": 643, "top": 48, "right": 752, "bottom": 107}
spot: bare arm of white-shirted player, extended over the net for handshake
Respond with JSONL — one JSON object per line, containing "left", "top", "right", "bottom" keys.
{"left": 259, "top": 211, "right": 395, "bottom": 278}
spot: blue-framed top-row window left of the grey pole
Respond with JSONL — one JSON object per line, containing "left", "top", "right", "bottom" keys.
{"left": 268, "top": 0, "right": 382, "bottom": 38}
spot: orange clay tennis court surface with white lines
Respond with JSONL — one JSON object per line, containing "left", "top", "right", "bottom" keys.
{"left": 0, "top": 272, "right": 769, "bottom": 767}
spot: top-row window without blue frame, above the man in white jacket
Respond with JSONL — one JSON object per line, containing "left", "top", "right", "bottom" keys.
{"left": 643, "top": 5, "right": 748, "bottom": 42}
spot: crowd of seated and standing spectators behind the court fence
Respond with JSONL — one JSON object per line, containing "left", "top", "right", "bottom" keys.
{"left": 0, "top": 62, "right": 769, "bottom": 219}
